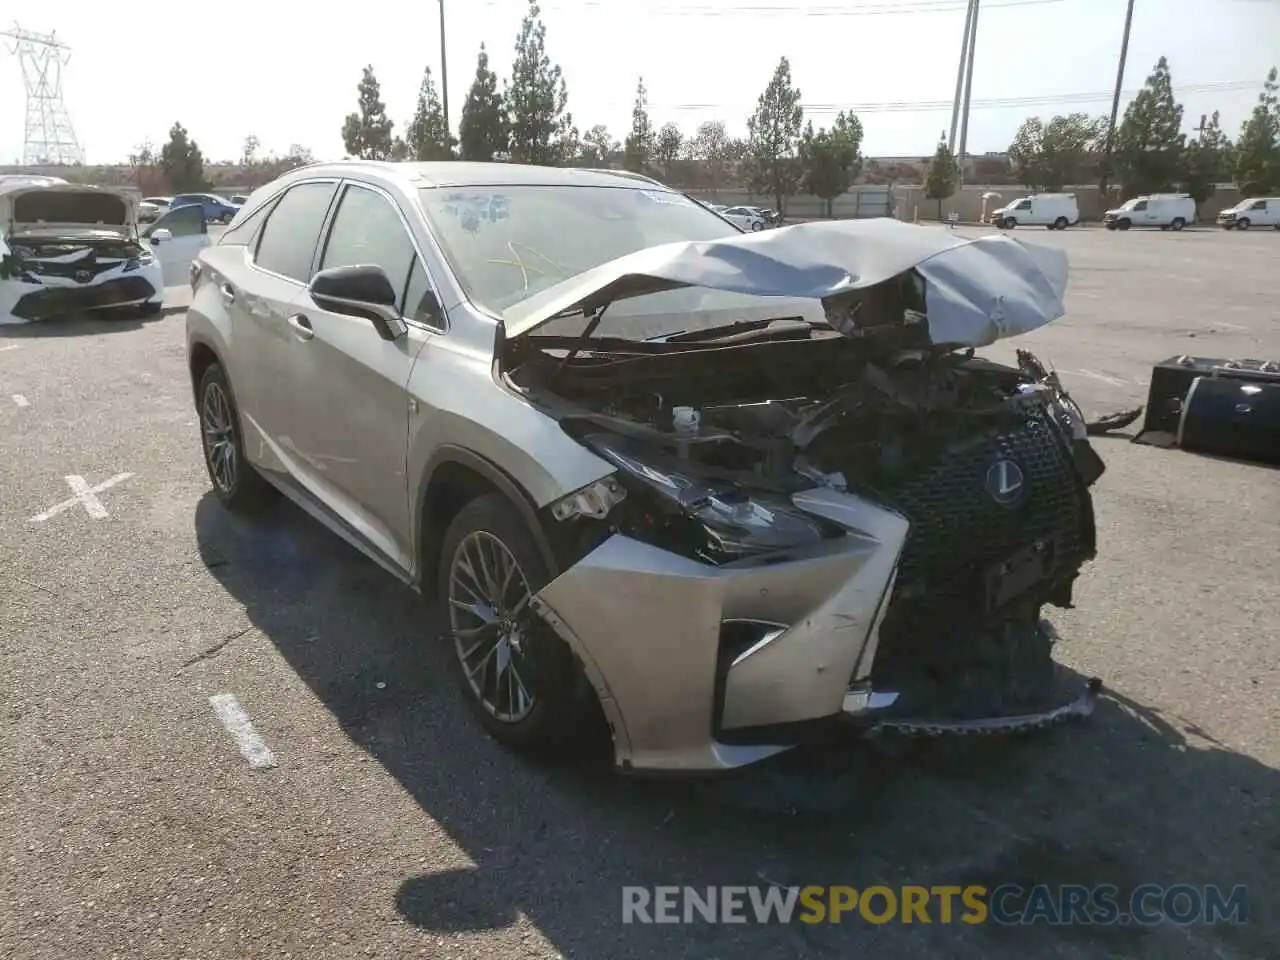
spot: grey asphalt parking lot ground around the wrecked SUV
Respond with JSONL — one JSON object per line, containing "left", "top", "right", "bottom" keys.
{"left": 0, "top": 230, "right": 1280, "bottom": 960}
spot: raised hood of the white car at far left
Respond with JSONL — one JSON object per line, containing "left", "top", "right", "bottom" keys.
{"left": 0, "top": 183, "right": 137, "bottom": 237}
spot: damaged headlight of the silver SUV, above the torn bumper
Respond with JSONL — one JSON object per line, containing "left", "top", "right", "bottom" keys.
{"left": 584, "top": 435, "right": 842, "bottom": 564}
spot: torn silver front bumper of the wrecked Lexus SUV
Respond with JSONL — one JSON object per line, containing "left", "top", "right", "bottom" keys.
{"left": 534, "top": 489, "right": 1096, "bottom": 772}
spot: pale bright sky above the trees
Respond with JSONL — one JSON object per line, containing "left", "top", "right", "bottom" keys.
{"left": 0, "top": 0, "right": 1280, "bottom": 163}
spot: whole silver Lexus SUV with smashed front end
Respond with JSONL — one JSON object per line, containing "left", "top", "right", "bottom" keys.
{"left": 187, "top": 161, "right": 1103, "bottom": 771}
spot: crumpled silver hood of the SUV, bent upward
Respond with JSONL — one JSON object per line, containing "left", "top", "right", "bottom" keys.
{"left": 502, "top": 218, "right": 1068, "bottom": 347}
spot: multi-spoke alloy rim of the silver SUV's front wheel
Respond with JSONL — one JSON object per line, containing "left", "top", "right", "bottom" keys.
{"left": 448, "top": 530, "right": 538, "bottom": 723}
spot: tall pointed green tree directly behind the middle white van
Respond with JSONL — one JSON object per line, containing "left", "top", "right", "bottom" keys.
{"left": 1112, "top": 56, "right": 1187, "bottom": 197}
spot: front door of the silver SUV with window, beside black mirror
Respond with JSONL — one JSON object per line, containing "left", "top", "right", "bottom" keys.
{"left": 275, "top": 182, "right": 442, "bottom": 570}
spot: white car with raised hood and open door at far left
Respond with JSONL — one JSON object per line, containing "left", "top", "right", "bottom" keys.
{"left": 0, "top": 180, "right": 209, "bottom": 324}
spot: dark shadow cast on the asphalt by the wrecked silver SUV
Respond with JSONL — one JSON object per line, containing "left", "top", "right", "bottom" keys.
{"left": 195, "top": 494, "right": 1280, "bottom": 960}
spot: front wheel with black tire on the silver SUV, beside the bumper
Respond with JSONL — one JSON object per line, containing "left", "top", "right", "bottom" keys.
{"left": 436, "top": 494, "right": 603, "bottom": 759}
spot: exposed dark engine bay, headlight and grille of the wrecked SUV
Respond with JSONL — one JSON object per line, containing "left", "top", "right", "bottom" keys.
{"left": 504, "top": 320, "right": 1105, "bottom": 719}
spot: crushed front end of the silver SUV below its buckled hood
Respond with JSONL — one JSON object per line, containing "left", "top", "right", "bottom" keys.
{"left": 502, "top": 220, "right": 1103, "bottom": 771}
